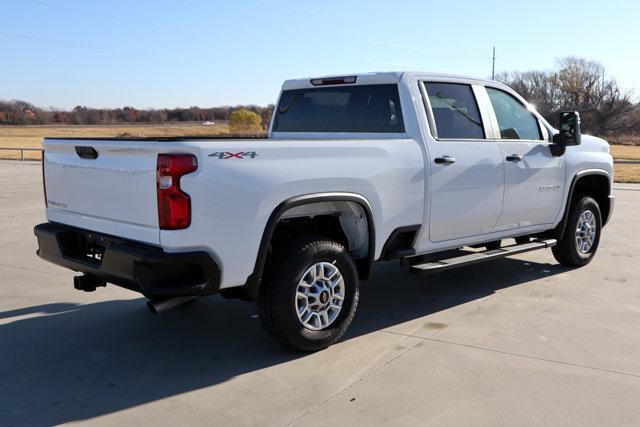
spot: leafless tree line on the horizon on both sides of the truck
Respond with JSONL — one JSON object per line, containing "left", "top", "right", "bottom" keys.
{"left": 0, "top": 57, "right": 640, "bottom": 136}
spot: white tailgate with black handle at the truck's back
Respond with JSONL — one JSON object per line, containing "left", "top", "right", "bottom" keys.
{"left": 43, "top": 139, "right": 160, "bottom": 244}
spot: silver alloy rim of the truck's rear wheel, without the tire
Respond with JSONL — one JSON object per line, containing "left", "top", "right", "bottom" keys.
{"left": 294, "top": 262, "right": 345, "bottom": 331}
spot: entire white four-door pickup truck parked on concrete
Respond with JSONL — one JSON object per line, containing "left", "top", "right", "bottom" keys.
{"left": 35, "top": 72, "right": 614, "bottom": 351}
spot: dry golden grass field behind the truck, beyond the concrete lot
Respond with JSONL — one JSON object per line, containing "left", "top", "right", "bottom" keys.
{"left": 0, "top": 123, "right": 640, "bottom": 183}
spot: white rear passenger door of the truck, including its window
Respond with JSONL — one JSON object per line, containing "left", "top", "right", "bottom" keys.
{"left": 421, "top": 81, "right": 504, "bottom": 242}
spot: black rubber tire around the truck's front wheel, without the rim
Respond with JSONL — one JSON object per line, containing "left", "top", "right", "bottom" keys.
{"left": 551, "top": 194, "right": 602, "bottom": 267}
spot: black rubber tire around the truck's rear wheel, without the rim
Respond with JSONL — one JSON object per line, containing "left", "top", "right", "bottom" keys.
{"left": 258, "top": 237, "right": 359, "bottom": 352}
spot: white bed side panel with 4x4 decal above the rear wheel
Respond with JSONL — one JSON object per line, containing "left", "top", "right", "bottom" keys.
{"left": 157, "top": 139, "right": 424, "bottom": 288}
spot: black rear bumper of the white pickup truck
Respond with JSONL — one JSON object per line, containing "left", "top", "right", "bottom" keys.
{"left": 34, "top": 222, "right": 220, "bottom": 296}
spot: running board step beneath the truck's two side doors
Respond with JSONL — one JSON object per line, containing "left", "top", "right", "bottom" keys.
{"left": 411, "top": 239, "right": 558, "bottom": 272}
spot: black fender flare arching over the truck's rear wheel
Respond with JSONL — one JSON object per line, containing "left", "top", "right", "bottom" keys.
{"left": 242, "top": 192, "right": 376, "bottom": 301}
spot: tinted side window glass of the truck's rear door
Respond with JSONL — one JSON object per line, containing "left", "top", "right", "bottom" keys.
{"left": 424, "top": 82, "right": 485, "bottom": 139}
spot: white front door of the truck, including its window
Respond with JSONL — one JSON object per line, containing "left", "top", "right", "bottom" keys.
{"left": 486, "top": 87, "right": 565, "bottom": 231}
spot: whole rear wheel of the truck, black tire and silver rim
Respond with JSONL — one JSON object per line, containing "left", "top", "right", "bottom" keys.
{"left": 258, "top": 238, "right": 359, "bottom": 352}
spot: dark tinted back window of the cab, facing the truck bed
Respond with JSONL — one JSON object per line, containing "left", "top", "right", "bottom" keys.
{"left": 273, "top": 84, "right": 404, "bottom": 133}
